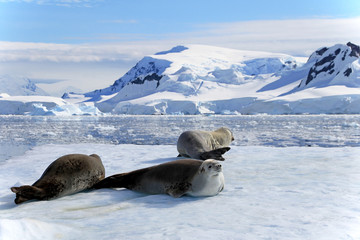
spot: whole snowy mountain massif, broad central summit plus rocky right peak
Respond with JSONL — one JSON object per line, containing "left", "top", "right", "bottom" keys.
{"left": 63, "top": 43, "right": 360, "bottom": 114}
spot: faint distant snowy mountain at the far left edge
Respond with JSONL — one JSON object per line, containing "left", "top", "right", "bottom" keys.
{"left": 0, "top": 75, "right": 48, "bottom": 96}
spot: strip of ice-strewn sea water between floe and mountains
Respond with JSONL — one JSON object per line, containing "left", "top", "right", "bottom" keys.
{"left": 0, "top": 115, "right": 360, "bottom": 161}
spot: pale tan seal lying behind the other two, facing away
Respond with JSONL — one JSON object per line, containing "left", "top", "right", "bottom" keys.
{"left": 177, "top": 127, "right": 234, "bottom": 161}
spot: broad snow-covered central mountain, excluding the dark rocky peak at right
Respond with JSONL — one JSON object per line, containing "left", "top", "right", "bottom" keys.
{"left": 65, "top": 45, "right": 299, "bottom": 114}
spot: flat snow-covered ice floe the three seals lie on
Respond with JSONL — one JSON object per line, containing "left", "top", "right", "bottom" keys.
{"left": 0, "top": 144, "right": 360, "bottom": 240}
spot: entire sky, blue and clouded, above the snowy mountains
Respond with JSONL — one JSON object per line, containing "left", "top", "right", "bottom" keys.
{"left": 0, "top": 0, "right": 360, "bottom": 95}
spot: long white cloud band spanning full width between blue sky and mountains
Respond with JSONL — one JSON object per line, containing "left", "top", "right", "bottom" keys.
{"left": 0, "top": 18, "right": 360, "bottom": 62}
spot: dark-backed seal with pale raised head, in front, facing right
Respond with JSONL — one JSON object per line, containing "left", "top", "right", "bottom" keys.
{"left": 94, "top": 159, "right": 225, "bottom": 198}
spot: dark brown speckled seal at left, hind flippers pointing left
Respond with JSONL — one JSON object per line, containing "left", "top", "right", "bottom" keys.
{"left": 11, "top": 154, "right": 105, "bottom": 204}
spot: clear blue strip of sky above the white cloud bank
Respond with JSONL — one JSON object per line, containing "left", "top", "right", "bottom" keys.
{"left": 0, "top": 0, "right": 360, "bottom": 43}
